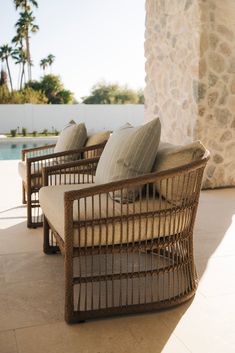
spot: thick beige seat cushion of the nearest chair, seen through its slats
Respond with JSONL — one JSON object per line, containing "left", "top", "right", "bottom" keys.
{"left": 39, "top": 184, "right": 192, "bottom": 247}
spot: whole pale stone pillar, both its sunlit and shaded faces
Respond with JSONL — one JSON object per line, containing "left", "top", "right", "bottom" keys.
{"left": 145, "top": 0, "right": 235, "bottom": 187}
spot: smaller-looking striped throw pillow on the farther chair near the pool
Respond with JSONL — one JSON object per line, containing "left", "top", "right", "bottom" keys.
{"left": 54, "top": 123, "right": 87, "bottom": 153}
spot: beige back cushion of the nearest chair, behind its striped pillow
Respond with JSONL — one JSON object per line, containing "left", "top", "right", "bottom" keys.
{"left": 152, "top": 141, "right": 206, "bottom": 204}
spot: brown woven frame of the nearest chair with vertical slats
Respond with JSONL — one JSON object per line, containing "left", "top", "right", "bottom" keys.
{"left": 40, "top": 152, "right": 209, "bottom": 323}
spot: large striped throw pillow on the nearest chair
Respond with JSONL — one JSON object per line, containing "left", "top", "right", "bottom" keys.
{"left": 95, "top": 119, "right": 161, "bottom": 202}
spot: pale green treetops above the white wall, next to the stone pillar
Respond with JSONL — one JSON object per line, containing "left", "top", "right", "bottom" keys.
{"left": 82, "top": 82, "right": 144, "bottom": 104}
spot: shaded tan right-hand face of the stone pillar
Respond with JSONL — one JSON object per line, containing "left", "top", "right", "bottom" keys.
{"left": 197, "top": 0, "right": 235, "bottom": 187}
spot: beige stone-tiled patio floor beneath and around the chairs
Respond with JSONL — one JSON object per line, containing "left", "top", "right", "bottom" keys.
{"left": 0, "top": 161, "right": 235, "bottom": 353}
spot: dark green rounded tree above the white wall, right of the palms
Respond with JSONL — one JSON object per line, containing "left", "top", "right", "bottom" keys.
{"left": 27, "top": 75, "right": 74, "bottom": 104}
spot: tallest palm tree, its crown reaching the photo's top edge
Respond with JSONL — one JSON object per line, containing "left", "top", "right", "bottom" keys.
{"left": 14, "top": 0, "right": 39, "bottom": 80}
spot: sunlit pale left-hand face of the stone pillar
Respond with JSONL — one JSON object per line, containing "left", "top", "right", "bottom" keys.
{"left": 145, "top": 0, "right": 199, "bottom": 143}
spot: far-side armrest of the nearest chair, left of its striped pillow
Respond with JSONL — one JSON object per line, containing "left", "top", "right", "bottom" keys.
{"left": 42, "top": 157, "right": 100, "bottom": 186}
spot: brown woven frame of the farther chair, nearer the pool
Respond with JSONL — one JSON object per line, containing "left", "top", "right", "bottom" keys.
{"left": 22, "top": 141, "right": 107, "bottom": 228}
